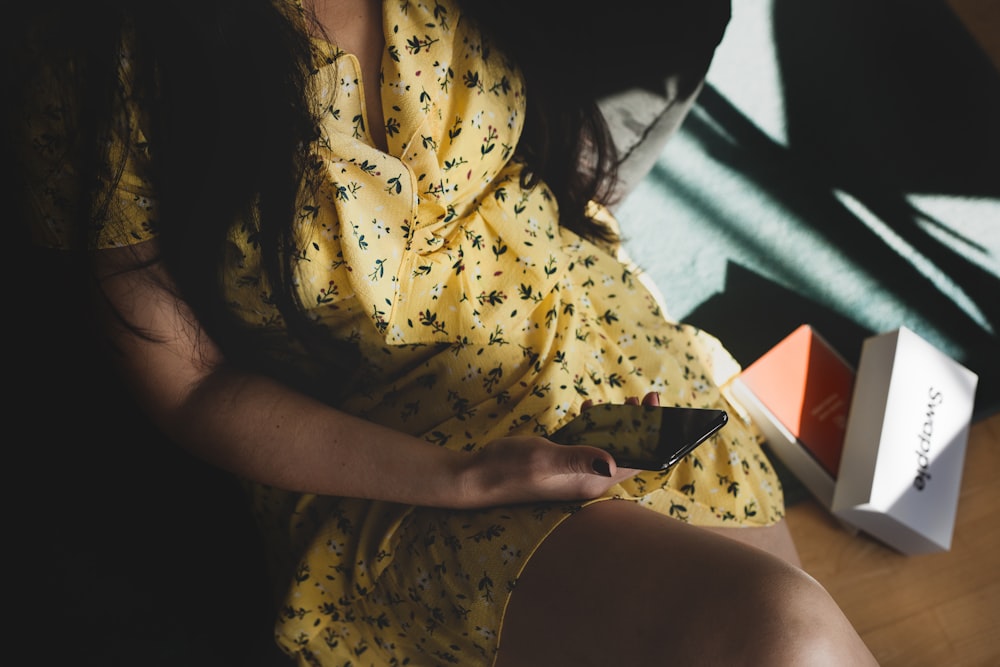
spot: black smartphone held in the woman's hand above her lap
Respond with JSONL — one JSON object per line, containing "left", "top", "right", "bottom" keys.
{"left": 550, "top": 403, "right": 729, "bottom": 471}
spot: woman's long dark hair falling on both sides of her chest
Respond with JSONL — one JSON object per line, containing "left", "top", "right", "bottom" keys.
{"left": 5, "top": 0, "right": 728, "bottom": 380}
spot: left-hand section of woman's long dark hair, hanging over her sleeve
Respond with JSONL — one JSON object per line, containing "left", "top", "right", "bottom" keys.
{"left": 4, "top": 0, "right": 315, "bottom": 366}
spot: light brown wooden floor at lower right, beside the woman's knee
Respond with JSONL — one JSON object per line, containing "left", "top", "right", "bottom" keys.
{"left": 788, "top": 414, "right": 1000, "bottom": 667}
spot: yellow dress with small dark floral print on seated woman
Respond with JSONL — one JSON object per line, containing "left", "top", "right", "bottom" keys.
{"left": 23, "top": 0, "right": 783, "bottom": 667}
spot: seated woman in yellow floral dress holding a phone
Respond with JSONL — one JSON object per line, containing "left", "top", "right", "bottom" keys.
{"left": 11, "top": 0, "right": 871, "bottom": 667}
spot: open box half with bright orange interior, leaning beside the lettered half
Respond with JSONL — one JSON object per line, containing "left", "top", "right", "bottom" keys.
{"left": 732, "top": 324, "right": 855, "bottom": 508}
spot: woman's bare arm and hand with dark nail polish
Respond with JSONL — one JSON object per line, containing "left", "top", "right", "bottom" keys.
{"left": 97, "top": 243, "right": 634, "bottom": 507}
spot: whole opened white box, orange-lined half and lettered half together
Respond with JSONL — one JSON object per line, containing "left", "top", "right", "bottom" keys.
{"left": 728, "top": 324, "right": 978, "bottom": 555}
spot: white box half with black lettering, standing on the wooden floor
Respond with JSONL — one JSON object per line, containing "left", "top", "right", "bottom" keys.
{"left": 831, "top": 327, "right": 979, "bottom": 554}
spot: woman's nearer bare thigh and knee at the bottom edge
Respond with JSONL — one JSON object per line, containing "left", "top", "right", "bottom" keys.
{"left": 496, "top": 501, "right": 876, "bottom": 667}
